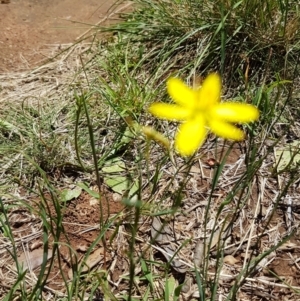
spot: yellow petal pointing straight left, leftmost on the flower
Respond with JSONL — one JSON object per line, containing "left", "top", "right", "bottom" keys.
{"left": 148, "top": 102, "right": 190, "bottom": 120}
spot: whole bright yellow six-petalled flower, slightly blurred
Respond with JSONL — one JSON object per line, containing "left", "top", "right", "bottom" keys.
{"left": 149, "top": 73, "right": 259, "bottom": 156}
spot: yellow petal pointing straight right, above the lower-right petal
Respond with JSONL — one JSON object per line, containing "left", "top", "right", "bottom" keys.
{"left": 211, "top": 102, "right": 259, "bottom": 123}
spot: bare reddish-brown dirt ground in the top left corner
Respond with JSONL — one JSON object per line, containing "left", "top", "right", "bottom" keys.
{"left": 0, "top": 0, "right": 130, "bottom": 73}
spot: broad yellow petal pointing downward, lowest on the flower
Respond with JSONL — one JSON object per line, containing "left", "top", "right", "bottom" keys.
{"left": 175, "top": 117, "right": 207, "bottom": 156}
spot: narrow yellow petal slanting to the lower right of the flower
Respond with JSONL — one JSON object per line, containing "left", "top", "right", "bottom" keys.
{"left": 209, "top": 119, "right": 245, "bottom": 140}
